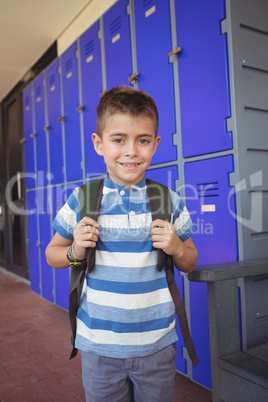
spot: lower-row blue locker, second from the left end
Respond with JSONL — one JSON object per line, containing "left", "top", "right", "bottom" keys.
{"left": 37, "top": 189, "right": 54, "bottom": 303}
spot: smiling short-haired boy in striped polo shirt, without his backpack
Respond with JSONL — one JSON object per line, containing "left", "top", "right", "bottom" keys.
{"left": 46, "top": 87, "right": 197, "bottom": 402}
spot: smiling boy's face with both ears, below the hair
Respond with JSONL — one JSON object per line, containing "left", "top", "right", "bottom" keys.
{"left": 92, "top": 113, "right": 160, "bottom": 187}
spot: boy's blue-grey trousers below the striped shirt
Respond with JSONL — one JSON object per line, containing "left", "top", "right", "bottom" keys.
{"left": 80, "top": 344, "right": 176, "bottom": 402}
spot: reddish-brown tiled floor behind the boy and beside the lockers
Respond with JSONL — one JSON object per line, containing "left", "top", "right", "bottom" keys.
{"left": 0, "top": 268, "right": 211, "bottom": 402}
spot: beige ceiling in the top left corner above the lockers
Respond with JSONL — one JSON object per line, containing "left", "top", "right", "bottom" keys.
{"left": 0, "top": 0, "right": 90, "bottom": 102}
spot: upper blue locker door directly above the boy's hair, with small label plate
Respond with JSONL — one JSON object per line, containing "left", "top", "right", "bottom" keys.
{"left": 103, "top": 0, "right": 132, "bottom": 89}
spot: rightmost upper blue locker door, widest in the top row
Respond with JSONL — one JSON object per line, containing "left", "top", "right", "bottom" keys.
{"left": 175, "top": 0, "right": 232, "bottom": 158}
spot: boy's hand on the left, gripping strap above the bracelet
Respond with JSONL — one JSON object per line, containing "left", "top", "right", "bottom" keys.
{"left": 73, "top": 216, "right": 99, "bottom": 259}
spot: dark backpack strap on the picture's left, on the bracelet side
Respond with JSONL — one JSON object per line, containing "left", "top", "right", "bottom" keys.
{"left": 69, "top": 180, "right": 104, "bottom": 360}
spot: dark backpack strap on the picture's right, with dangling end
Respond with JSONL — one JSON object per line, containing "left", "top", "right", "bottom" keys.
{"left": 146, "top": 179, "right": 199, "bottom": 366}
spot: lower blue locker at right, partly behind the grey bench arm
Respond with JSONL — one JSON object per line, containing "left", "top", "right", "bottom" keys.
{"left": 185, "top": 155, "right": 238, "bottom": 388}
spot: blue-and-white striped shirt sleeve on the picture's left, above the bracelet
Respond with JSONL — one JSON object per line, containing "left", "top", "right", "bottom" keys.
{"left": 53, "top": 187, "right": 80, "bottom": 240}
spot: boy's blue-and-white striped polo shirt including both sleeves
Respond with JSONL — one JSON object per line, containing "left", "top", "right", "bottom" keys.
{"left": 53, "top": 176, "right": 193, "bottom": 358}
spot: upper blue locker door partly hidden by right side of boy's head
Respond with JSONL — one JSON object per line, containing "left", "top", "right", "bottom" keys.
{"left": 134, "top": 0, "right": 177, "bottom": 164}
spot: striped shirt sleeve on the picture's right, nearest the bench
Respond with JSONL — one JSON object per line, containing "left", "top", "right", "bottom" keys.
{"left": 170, "top": 190, "right": 195, "bottom": 241}
